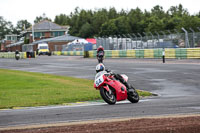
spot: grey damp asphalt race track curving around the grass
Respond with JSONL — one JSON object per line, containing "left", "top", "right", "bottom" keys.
{"left": 0, "top": 56, "right": 200, "bottom": 128}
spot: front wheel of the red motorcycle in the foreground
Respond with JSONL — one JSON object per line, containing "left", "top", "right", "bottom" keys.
{"left": 100, "top": 87, "right": 116, "bottom": 105}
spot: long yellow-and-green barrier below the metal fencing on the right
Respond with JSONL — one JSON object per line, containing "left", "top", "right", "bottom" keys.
{"left": 88, "top": 48, "right": 200, "bottom": 59}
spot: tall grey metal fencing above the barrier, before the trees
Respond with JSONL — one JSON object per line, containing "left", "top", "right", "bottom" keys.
{"left": 96, "top": 28, "right": 200, "bottom": 50}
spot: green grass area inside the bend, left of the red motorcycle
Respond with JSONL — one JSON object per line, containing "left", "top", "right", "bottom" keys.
{"left": 0, "top": 69, "right": 151, "bottom": 109}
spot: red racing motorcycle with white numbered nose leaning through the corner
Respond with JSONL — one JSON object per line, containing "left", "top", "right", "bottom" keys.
{"left": 94, "top": 71, "right": 139, "bottom": 105}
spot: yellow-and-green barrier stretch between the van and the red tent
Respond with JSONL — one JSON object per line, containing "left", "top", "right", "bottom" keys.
{"left": 53, "top": 51, "right": 84, "bottom": 56}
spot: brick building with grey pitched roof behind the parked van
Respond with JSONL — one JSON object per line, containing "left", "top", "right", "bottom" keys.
{"left": 6, "top": 20, "right": 80, "bottom": 52}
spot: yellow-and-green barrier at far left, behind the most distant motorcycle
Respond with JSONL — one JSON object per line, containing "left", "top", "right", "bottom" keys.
{"left": 0, "top": 52, "right": 27, "bottom": 59}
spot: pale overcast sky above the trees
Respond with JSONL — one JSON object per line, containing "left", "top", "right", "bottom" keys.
{"left": 0, "top": 0, "right": 200, "bottom": 25}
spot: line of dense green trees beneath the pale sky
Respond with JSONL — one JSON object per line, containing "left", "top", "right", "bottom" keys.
{"left": 0, "top": 4, "right": 200, "bottom": 38}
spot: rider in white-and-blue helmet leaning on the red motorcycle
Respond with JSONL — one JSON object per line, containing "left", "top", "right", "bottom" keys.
{"left": 96, "top": 63, "right": 131, "bottom": 91}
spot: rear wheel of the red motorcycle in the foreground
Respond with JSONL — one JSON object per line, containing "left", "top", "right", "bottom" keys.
{"left": 127, "top": 86, "right": 140, "bottom": 103}
